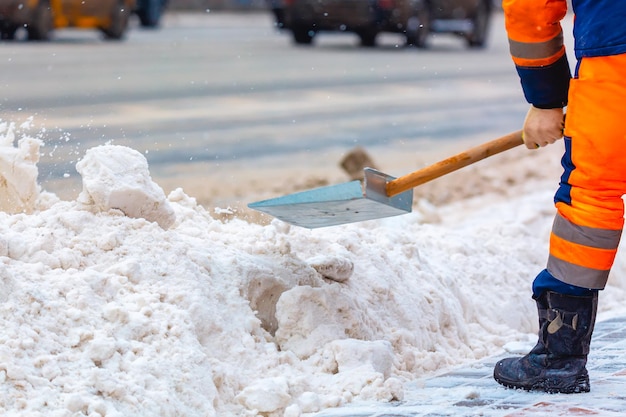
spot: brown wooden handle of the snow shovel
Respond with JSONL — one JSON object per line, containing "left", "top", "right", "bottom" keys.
{"left": 386, "top": 130, "right": 524, "bottom": 197}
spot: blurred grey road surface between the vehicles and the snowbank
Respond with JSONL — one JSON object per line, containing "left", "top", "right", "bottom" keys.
{"left": 0, "top": 12, "right": 526, "bottom": 207}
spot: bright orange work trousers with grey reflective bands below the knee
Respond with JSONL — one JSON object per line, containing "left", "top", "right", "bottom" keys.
{"left": 546, "top": 54, "right": 626, "bottom": 289}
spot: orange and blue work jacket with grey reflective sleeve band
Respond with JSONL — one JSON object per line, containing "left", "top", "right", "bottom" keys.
{"left": 502, "top": 0, "right": 626, "bottom": 108}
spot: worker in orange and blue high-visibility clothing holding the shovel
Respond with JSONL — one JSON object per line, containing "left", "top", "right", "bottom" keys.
{"left": 494, "top": 0, "right": 626, "bottom": 394}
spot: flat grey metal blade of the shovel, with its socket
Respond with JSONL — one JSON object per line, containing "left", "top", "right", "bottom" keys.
{"left": 248, "top": 168, "right": 413, "bottom": 229}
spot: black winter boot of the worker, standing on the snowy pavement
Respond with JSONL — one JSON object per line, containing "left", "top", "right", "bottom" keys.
{"left": 493, "top": 291, "right": 598, "bottom": 394}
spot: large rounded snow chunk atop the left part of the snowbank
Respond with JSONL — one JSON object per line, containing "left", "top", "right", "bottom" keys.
{"left": 76, "top": 145, "right": 176, "bottom": 229}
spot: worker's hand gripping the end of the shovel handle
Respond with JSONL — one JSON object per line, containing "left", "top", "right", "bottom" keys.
{"left": 522, "top": 106, "right": 565, "bottom": 149}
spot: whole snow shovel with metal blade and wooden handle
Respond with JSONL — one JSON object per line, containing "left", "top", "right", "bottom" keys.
{"left": 248, "top": 131, "right": 523, "bottom": 229}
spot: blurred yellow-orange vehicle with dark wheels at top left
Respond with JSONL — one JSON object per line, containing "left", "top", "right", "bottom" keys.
{"left": 0, "top": 0, "right": 135, "bottom": 40}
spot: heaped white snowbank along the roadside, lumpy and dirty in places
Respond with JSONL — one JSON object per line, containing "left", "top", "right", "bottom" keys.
{"left": 0, "top": 118, "right": 626, "bottom": 417}
